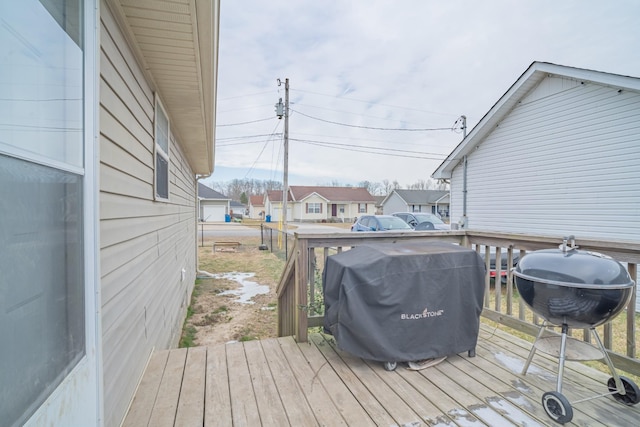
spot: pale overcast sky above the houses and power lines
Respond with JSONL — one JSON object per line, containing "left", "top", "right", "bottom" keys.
{"left": 209, "top": 0, "right": 640, "bottom": 187}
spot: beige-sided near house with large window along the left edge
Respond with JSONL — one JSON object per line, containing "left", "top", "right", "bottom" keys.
{"left": 0, "top": 0, "right": 220, "bottom": 427}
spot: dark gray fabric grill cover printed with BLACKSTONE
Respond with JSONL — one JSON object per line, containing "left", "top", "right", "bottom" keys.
{"left": 322, "top": 242, "right": 485, "bottom": 362}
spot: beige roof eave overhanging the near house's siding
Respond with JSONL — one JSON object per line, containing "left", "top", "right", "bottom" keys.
{"left": 106, "top": 0, "right": 220, "bottom": 175}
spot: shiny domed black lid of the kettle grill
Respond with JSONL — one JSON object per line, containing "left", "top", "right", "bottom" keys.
{"left": 513, "top": 240, "right": 635, "bottom": 289}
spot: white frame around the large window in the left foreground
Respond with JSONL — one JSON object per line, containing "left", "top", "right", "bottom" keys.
{"left": 0, "top": 0, "right": 103, "bottom": 427}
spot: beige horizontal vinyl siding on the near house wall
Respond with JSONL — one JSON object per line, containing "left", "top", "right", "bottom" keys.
{"left": 100, "top": 3, "right": 196, "bottom": 426}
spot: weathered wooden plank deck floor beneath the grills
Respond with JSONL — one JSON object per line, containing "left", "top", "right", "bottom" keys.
{"left": 124, "top": 324, "right": 640, "bottom": 427}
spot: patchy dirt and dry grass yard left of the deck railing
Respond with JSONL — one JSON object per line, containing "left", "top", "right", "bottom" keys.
{"left": 181, "top": 238, "right": 284, "bottom": 346}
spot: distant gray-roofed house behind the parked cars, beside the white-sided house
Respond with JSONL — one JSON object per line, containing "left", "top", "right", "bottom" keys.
{"left": 382, "top": 190, "right": 449, "bottom": 218}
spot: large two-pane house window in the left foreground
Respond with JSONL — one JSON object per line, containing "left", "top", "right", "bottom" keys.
{"left": 0, "top": 0, "right": 86, "bottom": 426}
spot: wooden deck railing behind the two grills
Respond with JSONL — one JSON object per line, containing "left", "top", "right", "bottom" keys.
{"left": 277, "top": 230, "right": 640, "bottom": 375}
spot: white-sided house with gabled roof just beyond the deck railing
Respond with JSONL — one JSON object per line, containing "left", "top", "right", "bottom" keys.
{"left": 432, "top": 62, "right": 640, "bottom": 241}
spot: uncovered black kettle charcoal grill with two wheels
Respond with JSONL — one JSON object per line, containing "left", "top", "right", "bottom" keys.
{"left": 513, "top": 236, "right": 640, "bottom": 424}
